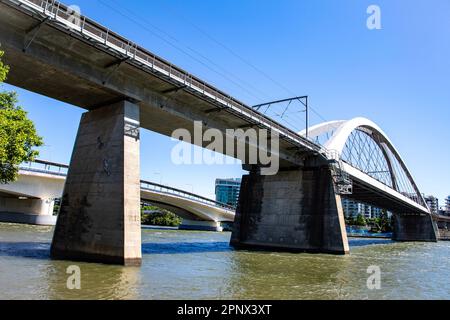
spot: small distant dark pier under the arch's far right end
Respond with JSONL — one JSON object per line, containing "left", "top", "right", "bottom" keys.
{"left": 392, "top": 214, "right": 439, "bottom": 242}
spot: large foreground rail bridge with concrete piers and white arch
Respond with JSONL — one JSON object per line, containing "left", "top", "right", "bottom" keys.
{"left": 0, "top": 0, "right": 437, "bottom": 264}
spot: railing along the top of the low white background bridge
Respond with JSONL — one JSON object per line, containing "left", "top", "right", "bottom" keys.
{"left": 19, "top": 160, "right": 236, "bottom": 211}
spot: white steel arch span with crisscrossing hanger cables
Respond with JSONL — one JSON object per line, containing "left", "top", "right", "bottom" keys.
{"left": 300, "top": 118, "right": 430, "bottom": 215}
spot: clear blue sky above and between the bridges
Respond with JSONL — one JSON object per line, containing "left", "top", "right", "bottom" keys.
{"left": 1, "top": 0, "right": 450, "bottom": 202}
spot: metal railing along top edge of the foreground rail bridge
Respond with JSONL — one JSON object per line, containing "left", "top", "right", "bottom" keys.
{"left": 7, "top": 0, "right": 321, "bottom": 153}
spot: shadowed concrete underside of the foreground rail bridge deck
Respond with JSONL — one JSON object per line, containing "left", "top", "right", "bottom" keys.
{"left": 0, "top": 2, "right": 311, "bottom": 167}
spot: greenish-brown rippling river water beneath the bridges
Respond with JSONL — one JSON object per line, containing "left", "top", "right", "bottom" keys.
{"left": 0, "top": 224, "right": 450, "bottom": 300}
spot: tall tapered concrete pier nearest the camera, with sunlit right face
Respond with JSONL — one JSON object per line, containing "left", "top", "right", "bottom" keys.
{"left": 51, "top": 101, "right": 141, "bottom": 265}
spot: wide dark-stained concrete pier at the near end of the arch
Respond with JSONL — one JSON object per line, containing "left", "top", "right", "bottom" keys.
{"left": 231, "top": 166, "right": 349, "bottom": 254}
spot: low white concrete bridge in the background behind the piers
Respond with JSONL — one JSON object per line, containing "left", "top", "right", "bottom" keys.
{"left": 0, "top": 160, "right": 235, "bottom": 231}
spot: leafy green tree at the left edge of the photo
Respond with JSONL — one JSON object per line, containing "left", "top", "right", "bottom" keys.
{"left": 0, "top": 51, "right": 43, "bottom": 183}
